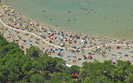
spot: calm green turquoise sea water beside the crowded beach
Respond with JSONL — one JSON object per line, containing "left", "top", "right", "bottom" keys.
{"left": 3, "top": 0, "right": 133, "bottom": 39}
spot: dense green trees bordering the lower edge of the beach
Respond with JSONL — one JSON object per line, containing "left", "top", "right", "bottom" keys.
{"left": 0, "top": 34, "right": 133, "bottom": 83}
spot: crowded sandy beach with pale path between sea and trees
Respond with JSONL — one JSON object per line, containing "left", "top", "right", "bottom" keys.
{"left": 0, "top": 5, "right": 133, "bottom": 66}
